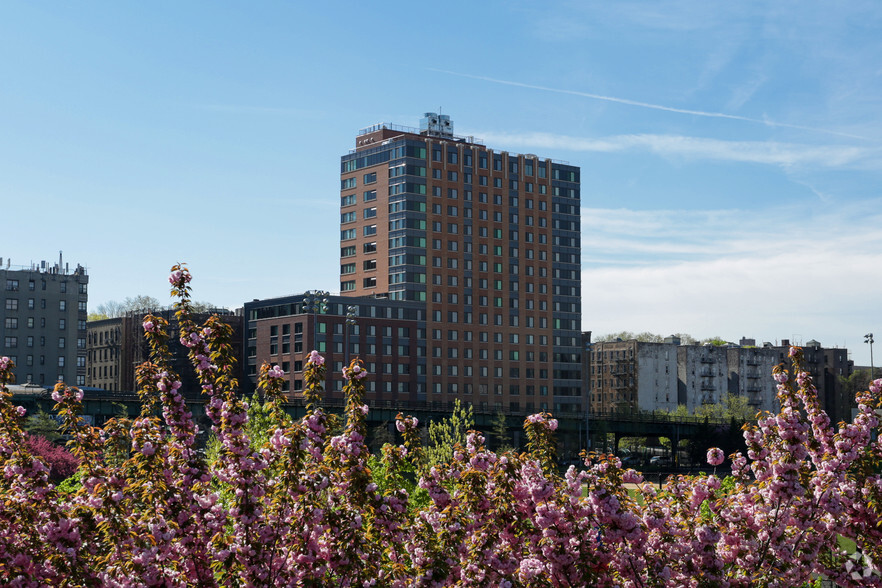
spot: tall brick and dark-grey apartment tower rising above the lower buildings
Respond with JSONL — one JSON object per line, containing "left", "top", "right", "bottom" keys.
{"left": 340, "top": 113, "right": 585, "bottom": 413}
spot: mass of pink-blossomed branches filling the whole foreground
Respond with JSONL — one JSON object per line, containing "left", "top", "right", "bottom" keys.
{"left": 0, "top": 273, "right": 882, "bottom": 588}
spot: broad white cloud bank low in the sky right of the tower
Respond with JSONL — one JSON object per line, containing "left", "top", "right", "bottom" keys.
{"left": 582, "top": 201, "right": 882, "bottom": 365}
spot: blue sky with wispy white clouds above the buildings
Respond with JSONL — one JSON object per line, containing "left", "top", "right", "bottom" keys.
{"left": 0, "top": 0, "right": 882, "bottom": 364}
